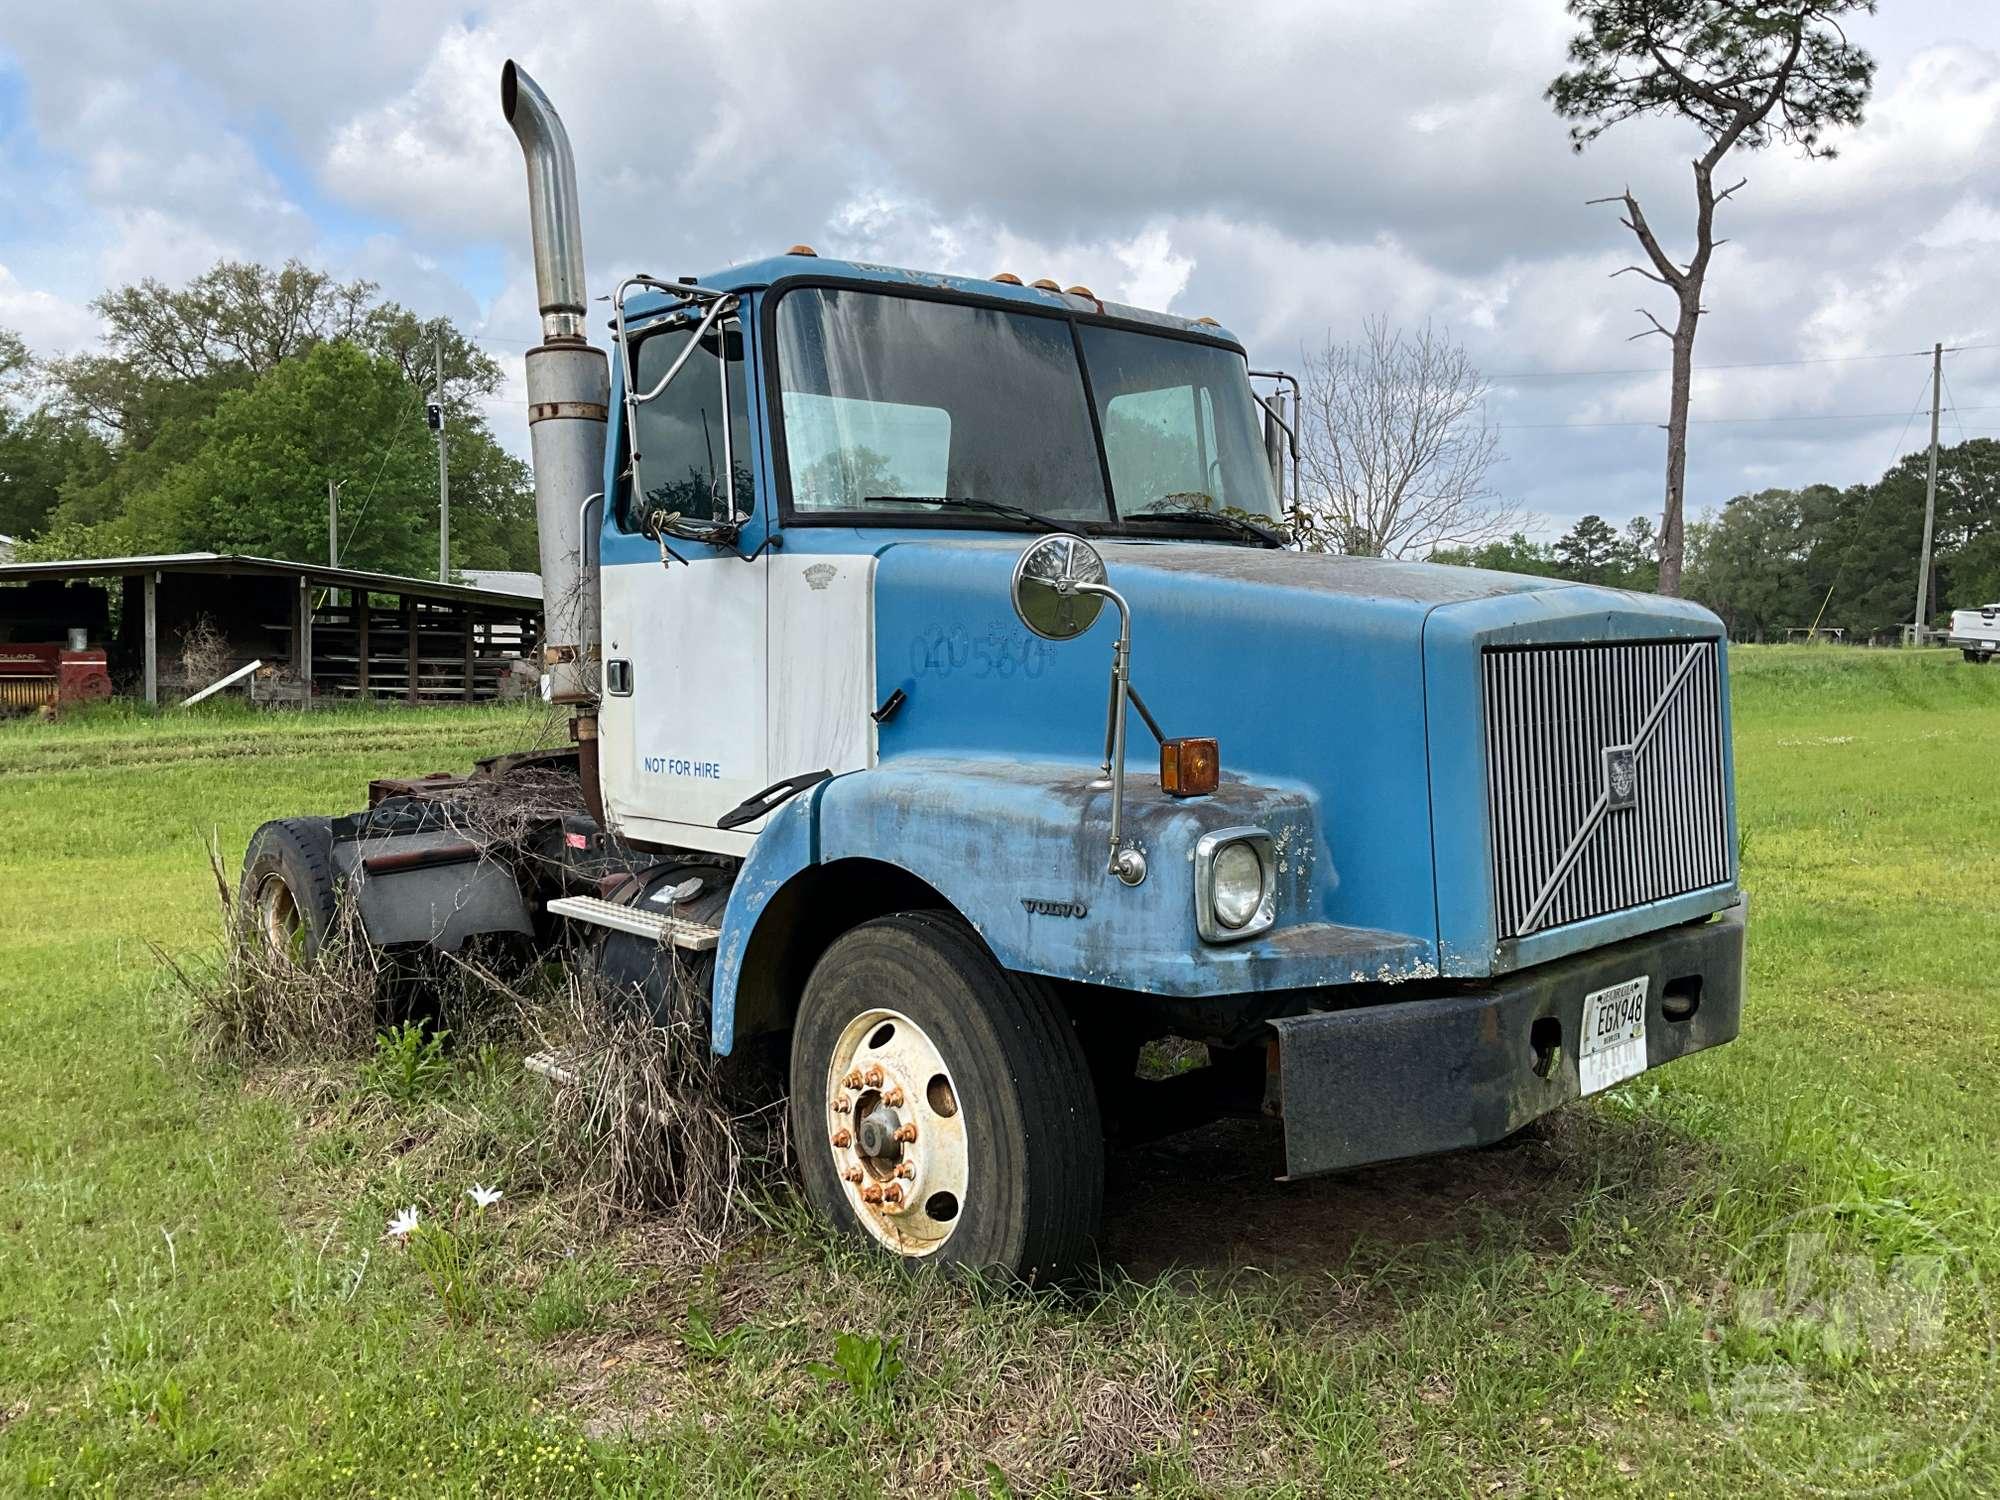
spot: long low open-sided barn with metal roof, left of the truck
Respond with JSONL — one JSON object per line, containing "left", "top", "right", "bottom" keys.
{"left": 0, "top": 552, "right": 542, "bottom": 708}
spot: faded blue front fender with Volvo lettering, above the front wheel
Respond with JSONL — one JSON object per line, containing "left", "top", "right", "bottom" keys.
{"left": 712, "top": 756, "right": 1438, "bottom": 1052}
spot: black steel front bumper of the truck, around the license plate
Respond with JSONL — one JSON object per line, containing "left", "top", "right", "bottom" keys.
{"left": 1270, "top": 904, "right": 1746, "bottom": 1178}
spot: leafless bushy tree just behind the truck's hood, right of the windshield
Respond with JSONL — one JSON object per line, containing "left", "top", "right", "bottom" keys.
{"left": 1292, "top": 318, "right": 1522, "bottom": 558}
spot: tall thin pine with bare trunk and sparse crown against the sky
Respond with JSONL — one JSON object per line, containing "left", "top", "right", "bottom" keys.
{"left": 1548, "top": 0, "right": 1874, "bottom": 594}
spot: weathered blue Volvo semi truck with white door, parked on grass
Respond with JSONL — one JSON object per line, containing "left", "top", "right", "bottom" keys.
{"left": 244, "top": 64, "right": 1744, "bottom": 1274}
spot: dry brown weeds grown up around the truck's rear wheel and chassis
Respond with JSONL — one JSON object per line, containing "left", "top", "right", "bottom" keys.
{"left": 170, "top": 824, "right": 786, "bottom": 1262}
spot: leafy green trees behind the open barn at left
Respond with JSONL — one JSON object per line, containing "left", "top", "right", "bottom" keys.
{"left": 0, "top": 260, "right": 536, "bottom": 576}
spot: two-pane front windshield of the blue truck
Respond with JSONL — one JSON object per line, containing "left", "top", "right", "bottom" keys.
{"left": 776, "top": 288, "right": 1276, "bottom": 526}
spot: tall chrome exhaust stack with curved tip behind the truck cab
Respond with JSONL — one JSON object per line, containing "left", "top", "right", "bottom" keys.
{"left": 500, "top": 62, "right": 610, "bottom": 712}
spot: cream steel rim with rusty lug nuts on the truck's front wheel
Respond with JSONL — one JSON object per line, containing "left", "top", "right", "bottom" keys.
{"left": 824, "top": 1010, "right": 970, "bottom": 1256}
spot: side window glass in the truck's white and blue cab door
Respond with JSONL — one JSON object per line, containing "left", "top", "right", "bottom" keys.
{"left": 618, "top": 322, "right": 756, "bottom": 532}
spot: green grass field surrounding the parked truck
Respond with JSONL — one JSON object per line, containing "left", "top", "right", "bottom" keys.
{"left": 0, "top": 648, "right": 2000, "bottom": 1500}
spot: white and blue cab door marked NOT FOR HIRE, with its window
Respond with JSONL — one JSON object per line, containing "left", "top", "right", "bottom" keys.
{"left": 598, "top": 302, "right": 772, "bottom": 854}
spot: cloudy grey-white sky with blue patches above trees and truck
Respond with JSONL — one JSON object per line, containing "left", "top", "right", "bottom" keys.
{"left": 0, "top": 0, "right": 2000, "bottom": 536}
